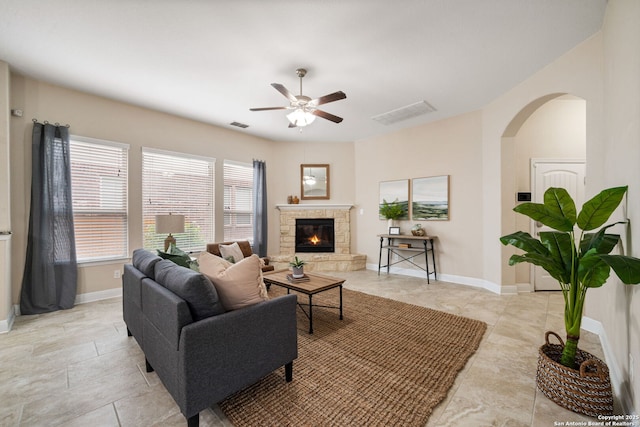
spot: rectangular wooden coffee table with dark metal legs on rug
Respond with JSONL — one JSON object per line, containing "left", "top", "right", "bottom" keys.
{"left": 263, "top": 270, "right": 345, "bottom": 334}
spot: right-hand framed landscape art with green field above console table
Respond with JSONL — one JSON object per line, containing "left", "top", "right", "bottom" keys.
{"left": 411, "top": 175, "right": 449, "bottom": 221}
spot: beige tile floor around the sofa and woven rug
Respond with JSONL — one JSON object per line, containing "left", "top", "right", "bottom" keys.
{"left": 0, "top": 271, "right": 620, "bottom": 427}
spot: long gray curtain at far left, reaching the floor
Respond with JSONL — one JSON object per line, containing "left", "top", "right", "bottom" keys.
{"left": 20, "top": 122, "right": 78, "bottom": 314}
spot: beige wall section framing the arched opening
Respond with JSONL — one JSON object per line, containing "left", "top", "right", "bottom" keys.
{"left": 488, "top": 33, "right": 603, "bottom": 287}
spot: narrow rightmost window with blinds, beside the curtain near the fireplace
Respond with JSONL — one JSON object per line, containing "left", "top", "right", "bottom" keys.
{"left": 224, "top": 160, "right": 253, "bottom": 243}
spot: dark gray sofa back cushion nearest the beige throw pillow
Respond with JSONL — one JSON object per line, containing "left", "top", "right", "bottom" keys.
{"left": 155, "top": 260, "right": 225, "bottom": 321}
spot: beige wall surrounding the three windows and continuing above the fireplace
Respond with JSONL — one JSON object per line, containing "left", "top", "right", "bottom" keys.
{"left": 6, "top": 74, "right": 353, "bottom": 304}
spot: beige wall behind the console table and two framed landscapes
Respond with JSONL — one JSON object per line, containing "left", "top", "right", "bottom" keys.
{"left": 355, "top": 112, "right": 482, "bottom": 281}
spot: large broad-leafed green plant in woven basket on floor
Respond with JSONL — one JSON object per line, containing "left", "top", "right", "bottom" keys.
{"left": 500, "top": 186, "right": 640, "bottom": 417}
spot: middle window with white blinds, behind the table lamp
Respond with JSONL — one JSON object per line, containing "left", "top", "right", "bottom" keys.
{"left": 142, "top": 148, "right": 215, "bottom": 252}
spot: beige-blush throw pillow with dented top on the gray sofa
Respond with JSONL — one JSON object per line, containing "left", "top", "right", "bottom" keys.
{"left": 199, "top": 252, "right": 269, "bottom": 310}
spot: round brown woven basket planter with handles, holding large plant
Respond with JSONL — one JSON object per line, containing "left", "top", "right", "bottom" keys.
{"left": 536, "top": 331, "right": 613, "bottom": 417}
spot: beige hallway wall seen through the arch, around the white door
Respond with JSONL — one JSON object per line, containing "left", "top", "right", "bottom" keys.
{"left": 501, "top": 93, "right": 586, "bottom": 292}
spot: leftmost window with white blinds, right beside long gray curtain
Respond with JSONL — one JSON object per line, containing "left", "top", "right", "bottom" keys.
{"left": 69, "top": 135, "right": 129, "bottom": 262}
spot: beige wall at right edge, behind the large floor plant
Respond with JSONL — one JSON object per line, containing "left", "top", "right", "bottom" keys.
{"left": 585, "top": 0, "right": 640, "bottom": 411}
